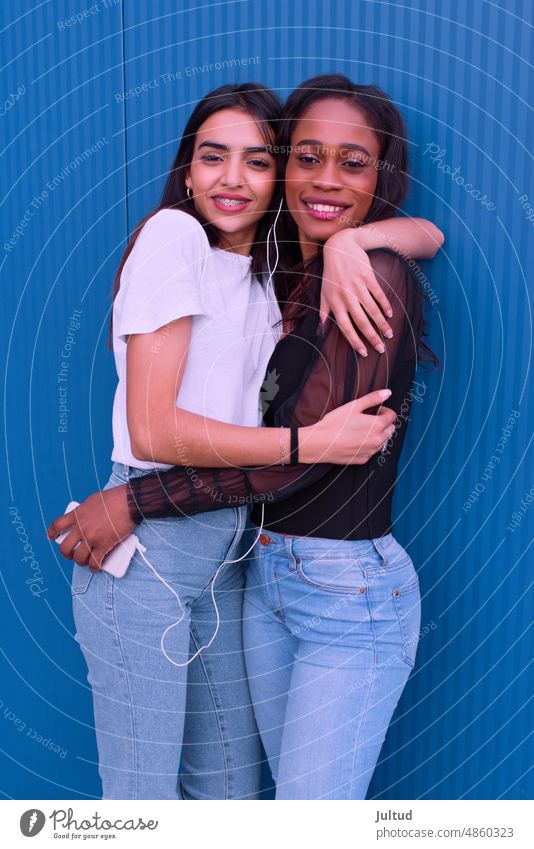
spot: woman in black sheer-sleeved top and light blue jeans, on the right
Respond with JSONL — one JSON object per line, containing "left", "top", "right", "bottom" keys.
{"left": 49, "top": 75, "right": 440, "bottom": 799}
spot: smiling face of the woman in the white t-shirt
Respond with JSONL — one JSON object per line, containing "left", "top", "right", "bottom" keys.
{"left": 186, "top": 109, "right": 276, "bottom": 255}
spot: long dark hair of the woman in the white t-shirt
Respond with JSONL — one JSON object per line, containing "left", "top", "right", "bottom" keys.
{"left": 110, "top": 83, "right": 283, "bottom": 347}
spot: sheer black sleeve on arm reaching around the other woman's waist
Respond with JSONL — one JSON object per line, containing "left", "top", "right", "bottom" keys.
{"left": 128, "top": 250, "right": 422, "bottom": 523}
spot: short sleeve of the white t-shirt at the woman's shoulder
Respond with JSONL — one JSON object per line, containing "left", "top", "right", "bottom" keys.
{"left": 113, "top": 209, "right": 210, "bottom": 337}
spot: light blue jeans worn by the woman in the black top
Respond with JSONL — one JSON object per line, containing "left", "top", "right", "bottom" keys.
{"left": 244, "top": 529, "right": 420, "bottom": 799}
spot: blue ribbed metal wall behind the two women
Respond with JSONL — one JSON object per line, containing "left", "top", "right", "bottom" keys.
{"left": 0, "top": 0, "right": 534, "bottom": 799}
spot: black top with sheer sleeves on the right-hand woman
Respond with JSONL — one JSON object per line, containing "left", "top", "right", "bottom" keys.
{"left": 128, "top": 249, "right": 423, "bottom": 540}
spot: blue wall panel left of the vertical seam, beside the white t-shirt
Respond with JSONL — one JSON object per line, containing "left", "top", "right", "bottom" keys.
{"left": 0, "top": 3, "right": 126, "bottom": 798}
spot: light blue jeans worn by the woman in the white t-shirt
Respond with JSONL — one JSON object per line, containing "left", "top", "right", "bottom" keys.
{"left": 72, "top": 464, "right": 262, "bottom": 799}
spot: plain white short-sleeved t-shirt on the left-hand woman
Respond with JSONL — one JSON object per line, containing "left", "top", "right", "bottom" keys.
{"left": 111, "top": 209, "right": 280, "bottom": 469}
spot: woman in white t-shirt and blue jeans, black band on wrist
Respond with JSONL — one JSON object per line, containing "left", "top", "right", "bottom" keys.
{"left": 49, "top": 84, "right": 444, "bottom": 799}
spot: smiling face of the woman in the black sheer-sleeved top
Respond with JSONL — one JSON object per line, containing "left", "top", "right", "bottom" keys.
{"left": 285, "top": 98, "right": 380, "bottom": 258}
